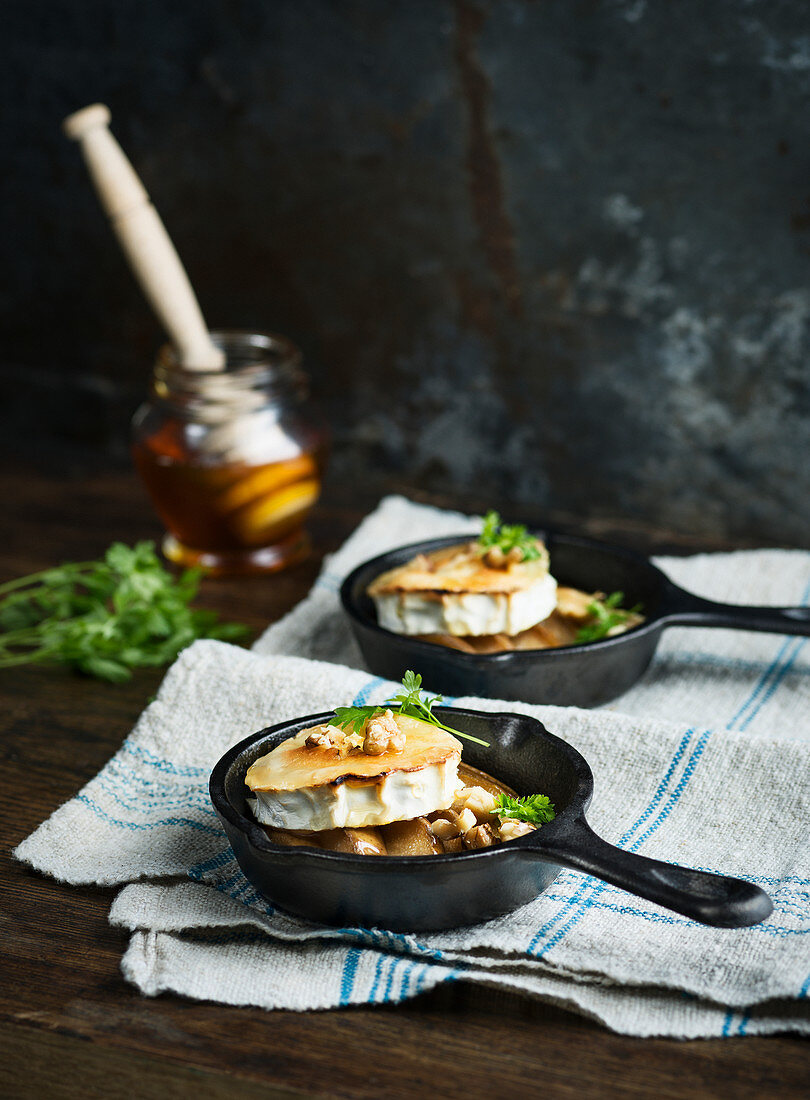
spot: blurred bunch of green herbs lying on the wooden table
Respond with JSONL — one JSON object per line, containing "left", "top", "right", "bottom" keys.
{"left": 0, "top": 542, "right": 247, "bottom": 683}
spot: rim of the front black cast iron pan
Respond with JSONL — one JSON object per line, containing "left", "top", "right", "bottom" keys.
{"left": 208, "top": 706, "right": 593, "bottom": 871}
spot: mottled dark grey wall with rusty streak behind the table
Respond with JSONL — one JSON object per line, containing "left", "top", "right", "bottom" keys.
{"left": 0, "top": 0, "right": 810, "bottom": 546}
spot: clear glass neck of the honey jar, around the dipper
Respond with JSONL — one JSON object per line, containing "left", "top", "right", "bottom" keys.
{"left": 151, "top": 331, "right": 309, "bottom": 419}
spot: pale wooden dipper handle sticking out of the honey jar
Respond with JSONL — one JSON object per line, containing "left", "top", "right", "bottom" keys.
{"left": 63, "top": 103, "right": 225, "bottom": 370}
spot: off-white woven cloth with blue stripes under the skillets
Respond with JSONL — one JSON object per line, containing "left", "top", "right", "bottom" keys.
{"left": 15, "top": 497, "right": 810, "bottom": 1037}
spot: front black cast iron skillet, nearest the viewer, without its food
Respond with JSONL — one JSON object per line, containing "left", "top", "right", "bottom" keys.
{"left": 209, "top": 707, "right": 773, "bottom": 932}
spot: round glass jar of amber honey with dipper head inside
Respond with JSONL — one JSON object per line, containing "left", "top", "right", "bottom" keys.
{"left": 132, "top": 331, "right": 328, "bottom": 575}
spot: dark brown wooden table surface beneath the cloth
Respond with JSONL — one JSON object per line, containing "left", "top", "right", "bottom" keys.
{"left": 0, "top": 471, "right": 810, "bottom": 1100}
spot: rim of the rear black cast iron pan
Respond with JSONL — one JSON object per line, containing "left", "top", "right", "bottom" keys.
{"left": 340, "top": 528, "right": 671, "bottom": 666}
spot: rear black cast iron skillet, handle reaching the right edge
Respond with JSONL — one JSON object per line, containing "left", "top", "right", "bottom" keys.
{"left": 340, "top": 531, "right": 810, "bottom": 706}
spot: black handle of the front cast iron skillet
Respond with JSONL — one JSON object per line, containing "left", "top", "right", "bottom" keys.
{"left": 524, "top": 816, "right": 774, "bottom": 928}
